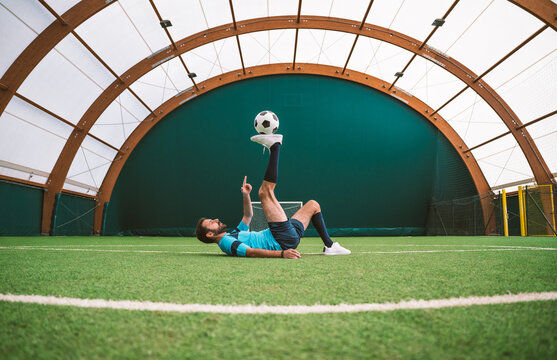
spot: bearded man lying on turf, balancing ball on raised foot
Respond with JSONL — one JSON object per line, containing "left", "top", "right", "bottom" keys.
{"left": 195, "top": 134, "right": 350, "bottom": 259}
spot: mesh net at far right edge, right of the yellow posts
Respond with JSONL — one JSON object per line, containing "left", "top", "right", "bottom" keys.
{"left": 524, "top": 185, "right": 555, "bottom": 236}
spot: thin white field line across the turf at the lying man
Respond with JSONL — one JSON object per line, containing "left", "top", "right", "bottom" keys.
{"left": 0, "top": 246, "right": 557, "bottom": 255}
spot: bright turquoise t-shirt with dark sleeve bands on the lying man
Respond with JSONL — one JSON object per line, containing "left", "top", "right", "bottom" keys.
{"left": 215, "top": 221, "right": 282, "bottom": 256}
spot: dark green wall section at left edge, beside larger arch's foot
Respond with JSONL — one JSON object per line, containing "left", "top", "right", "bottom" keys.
{"left": 0, "top": 180, "right": 43, "bottom": 236}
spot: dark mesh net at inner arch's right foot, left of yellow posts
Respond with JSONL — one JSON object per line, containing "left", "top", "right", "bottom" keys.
{"left": 426, "top": 194, "right": 504, "bottom": 236}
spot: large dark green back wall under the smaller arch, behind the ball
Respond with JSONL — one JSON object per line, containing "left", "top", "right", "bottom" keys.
{"left": 105, "top": 75, "right": 475, "bottom": 234}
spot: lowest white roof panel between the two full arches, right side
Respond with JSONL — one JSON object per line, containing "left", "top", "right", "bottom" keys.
{"left": 472, "top": 135, "right": 534, "bottom": 187}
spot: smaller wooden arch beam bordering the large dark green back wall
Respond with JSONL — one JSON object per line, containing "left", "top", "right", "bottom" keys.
{"left": 95, "top": 63, "right": 491, "bottom": 234}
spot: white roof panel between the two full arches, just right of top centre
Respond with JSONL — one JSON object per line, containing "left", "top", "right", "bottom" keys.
{"left": 296, "top": 29, "right": 356, "bottom": 67}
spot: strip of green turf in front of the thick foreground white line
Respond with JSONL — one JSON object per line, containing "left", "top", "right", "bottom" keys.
{"left": 0, "top": 301, "right": 557, "bottom": 359}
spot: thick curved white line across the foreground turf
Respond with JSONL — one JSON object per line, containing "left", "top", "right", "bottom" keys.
{"left": 0, "top": 292, "right": 557, "bottom": 314}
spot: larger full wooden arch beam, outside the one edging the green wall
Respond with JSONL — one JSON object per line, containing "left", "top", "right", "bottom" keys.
{"left": 37, "top": 16, "right": 554, "bottom": 232}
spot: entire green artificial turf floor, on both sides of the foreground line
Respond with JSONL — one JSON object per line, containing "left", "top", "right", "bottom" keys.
{"left": 0, "top": 237, "right": 557, "bottom": 359}
